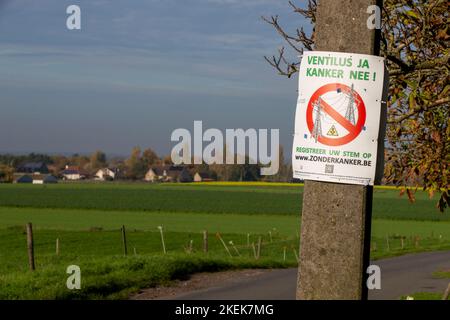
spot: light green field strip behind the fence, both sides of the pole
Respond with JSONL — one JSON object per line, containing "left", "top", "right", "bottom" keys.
{"left": 0, "top": 207, "right": 450, "bottom": 241}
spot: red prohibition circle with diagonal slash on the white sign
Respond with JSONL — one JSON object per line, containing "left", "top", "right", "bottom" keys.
{"left": 306, "top": 83, "right": 366, "bottom": 146}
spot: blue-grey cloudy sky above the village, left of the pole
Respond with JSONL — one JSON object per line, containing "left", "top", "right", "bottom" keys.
{"left": 0, "top": 0, "right": 310, "bottom": 155}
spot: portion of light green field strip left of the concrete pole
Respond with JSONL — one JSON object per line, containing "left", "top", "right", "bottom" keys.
{"left": 0, "top": 207, "right": 300, "bottom": 235}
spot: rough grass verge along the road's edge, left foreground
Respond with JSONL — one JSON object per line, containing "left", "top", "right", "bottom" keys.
{"left": 0, "top": 254, "right": 294, "bottom": 299}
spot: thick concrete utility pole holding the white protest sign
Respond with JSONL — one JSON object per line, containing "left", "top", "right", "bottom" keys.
{"left": 297, "top": 0, "right": 384, "bottom": 300}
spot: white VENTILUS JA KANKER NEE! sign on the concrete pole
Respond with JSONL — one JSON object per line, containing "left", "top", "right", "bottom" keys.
{"left": 292, "top": 51, "right": 387, "bottom": 185}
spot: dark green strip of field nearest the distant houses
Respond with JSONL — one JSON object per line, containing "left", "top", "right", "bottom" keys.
{"left": 0, "top": 183, "right": 450, "bottom": 221}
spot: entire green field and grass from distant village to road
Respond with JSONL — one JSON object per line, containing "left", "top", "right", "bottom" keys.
{"left": 0, "top": 183, "right": 450, "bottom": 299}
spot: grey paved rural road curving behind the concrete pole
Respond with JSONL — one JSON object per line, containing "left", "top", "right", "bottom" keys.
{"left": 163, "top": 251, "right": 450, "bottom": 300}
